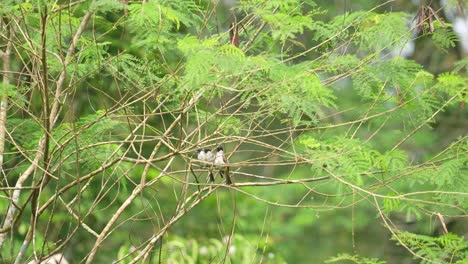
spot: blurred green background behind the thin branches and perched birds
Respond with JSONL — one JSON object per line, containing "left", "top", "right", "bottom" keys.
{"left": 0, "top": 0, "right": 468, "bottom": 263}
